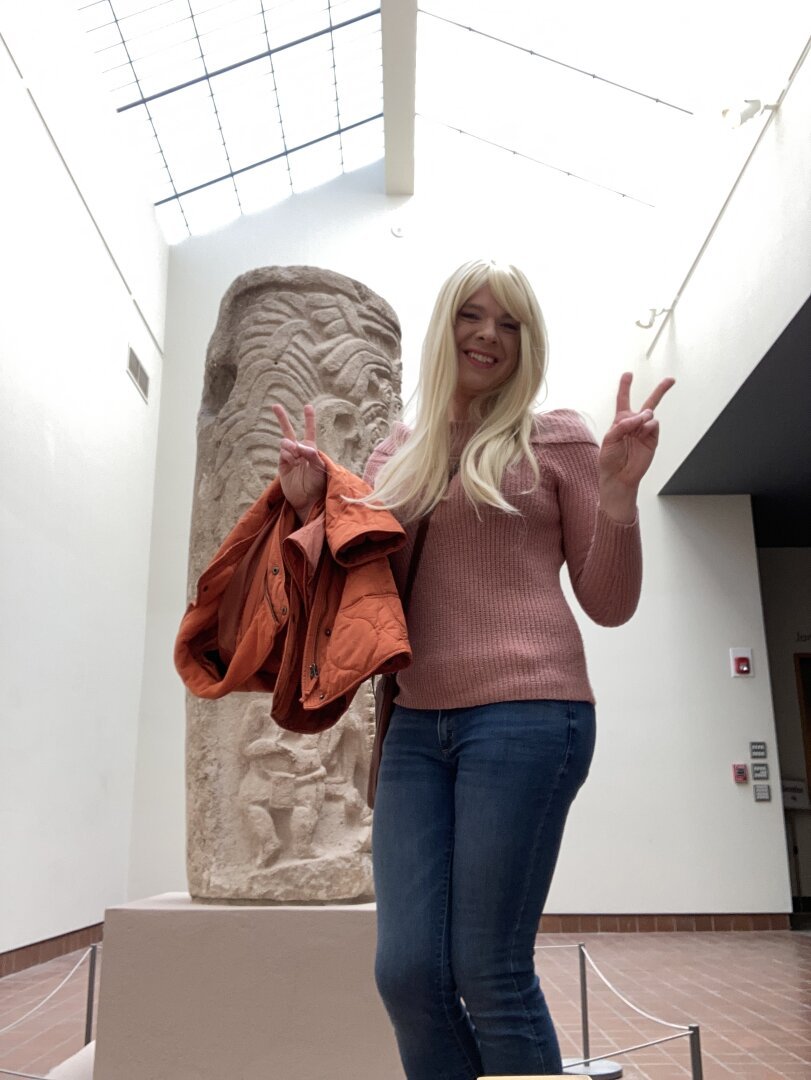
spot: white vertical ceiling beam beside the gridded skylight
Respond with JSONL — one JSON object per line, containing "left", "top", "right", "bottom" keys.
{"left": 380, "top": 0, "right": 417, "bottom": 195}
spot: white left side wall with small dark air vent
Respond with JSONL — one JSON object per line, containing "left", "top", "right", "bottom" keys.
{"left": 0, "top": 0, "right": 167, "bottom": 951}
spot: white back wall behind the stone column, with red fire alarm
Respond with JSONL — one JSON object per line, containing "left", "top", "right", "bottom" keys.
{"left": 131, "top": 88, "right": 788, "bottom": 912}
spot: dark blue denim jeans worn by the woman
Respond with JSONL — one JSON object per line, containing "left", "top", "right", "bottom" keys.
{"left": 373, "top": 701, "right": 594, "bottom": 1080}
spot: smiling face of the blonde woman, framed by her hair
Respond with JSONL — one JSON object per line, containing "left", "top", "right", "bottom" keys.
{"left": 451, "top": 285, "right": 521, "bottom": 420}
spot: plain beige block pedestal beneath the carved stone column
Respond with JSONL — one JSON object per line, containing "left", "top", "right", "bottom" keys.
{"left": 93, "top": 893, "right": 403, "bottom": 1080}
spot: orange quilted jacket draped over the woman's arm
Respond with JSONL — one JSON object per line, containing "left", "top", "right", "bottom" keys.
{"left": 175, "top": 455, "right": 411, "bottom": 732}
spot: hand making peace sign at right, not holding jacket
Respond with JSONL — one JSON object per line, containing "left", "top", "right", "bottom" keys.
{"left": 598, "top": 372, "right": 676, "bottom": 521}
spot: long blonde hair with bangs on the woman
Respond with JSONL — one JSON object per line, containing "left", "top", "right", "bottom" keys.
{"left": 364, "top": 259, "right": 548, "bottom": 521}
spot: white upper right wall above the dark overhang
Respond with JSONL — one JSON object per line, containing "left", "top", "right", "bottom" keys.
{"left": 644, "top": 32, "right": 811, "bottom": 483}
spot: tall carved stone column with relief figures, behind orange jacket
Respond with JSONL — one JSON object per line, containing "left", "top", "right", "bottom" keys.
{"left": 187, "top": 267, "right": 401, "bottom": 903}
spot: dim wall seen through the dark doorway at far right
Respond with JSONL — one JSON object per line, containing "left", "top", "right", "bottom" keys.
{"left": 757, "top": 548, "right": 811, "bottom": 896}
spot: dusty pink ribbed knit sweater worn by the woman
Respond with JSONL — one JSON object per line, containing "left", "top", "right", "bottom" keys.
{"left": 364, "top": 409, "right": 641, "bottom": 708}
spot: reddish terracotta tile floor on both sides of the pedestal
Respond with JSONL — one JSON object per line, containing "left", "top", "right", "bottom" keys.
{"left": 0, "top": 931, "right": 811, "bottom": 1080}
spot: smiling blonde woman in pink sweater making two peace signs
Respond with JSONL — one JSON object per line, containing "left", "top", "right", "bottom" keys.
{"left": 275, "top": 261, "right": 673, "bottom": 1080}
